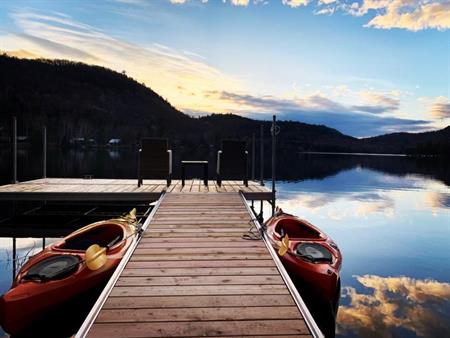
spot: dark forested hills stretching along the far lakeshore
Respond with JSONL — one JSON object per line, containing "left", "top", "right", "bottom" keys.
{"left": 0, "top": 55, "right": 450, "bottom": 153}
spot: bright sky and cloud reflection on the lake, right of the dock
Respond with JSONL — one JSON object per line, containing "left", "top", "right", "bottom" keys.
{"left": 265, "top": 163, "right": 450, "bottom": 337}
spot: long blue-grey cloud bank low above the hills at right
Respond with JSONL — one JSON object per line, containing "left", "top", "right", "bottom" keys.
{"left": 207, "top": 91, "right": 430, "bottom": 137}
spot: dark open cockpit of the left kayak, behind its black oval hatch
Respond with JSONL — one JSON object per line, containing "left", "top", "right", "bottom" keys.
{"left": 55, "top": 223, "right": 124, "bottom": 251}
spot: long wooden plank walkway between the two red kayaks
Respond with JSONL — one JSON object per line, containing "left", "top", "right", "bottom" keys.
{"left": 75, "top": 193, "right": 323, "bottom": 337}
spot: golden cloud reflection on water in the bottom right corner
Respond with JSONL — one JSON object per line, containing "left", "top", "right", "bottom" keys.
{"left": 337, "top": 275, "right": 450, "bottom": 338}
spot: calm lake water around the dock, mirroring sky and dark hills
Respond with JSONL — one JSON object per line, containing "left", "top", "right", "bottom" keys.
{"left": 0, "top": 150, "right": 450, "bottom": 337}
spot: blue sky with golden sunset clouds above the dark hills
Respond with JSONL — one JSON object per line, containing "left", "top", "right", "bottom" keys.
{"left": 0, "top": 0, "right": 450, "bottom": 137}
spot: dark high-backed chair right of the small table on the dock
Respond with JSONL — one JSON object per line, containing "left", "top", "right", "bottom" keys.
{"left": 217, "top": 140, "right": 248, "bottom": 187}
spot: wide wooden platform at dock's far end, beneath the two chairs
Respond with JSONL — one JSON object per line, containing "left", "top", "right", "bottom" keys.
{"left": 0, "top": 178, "right": 271, "bottom": 201}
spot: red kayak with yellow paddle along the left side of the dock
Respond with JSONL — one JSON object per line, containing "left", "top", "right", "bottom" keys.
{"left": 0, "top": 215, "right": 136, "bottom": 334}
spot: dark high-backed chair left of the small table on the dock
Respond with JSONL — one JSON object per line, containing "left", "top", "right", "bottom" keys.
{"left": 138, "top": 138, "right": 172, "bottom": 187}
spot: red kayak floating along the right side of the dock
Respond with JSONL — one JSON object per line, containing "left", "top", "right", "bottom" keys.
{"left": 265, "top": 208, "right": 342, "bottom": 307}
